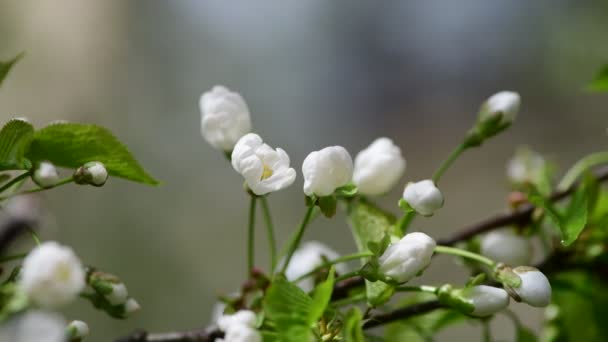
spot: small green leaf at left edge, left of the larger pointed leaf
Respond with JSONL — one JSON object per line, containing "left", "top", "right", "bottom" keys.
{"left": 0, "top": 119, "right": 34, "bottom": 171}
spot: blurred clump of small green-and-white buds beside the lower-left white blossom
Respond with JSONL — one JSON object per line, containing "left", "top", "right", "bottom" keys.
{"left": 85, "top": 270, "right": 140, "bottom": 318}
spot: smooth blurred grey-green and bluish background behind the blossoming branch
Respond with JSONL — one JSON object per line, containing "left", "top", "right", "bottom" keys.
{"left": 0, "top": 0, "right": 608, "bottom": 341}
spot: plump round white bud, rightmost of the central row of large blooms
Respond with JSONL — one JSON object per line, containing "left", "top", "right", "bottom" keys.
{"left": 353, "top": 138, "right": 406, "bottom": 196}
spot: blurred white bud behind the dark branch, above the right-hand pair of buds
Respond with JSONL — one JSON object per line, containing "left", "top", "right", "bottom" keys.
{"left": 480, "top": 229, "right": 532, "bottom": 265}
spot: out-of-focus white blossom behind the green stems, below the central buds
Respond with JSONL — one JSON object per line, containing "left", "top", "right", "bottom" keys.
{"left": 281, "top": 241, "right": 348, "bottom": 292}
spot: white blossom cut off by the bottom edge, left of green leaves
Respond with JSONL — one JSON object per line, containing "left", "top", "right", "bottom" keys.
{"left": 216, "top": 310, "right": 262, "bottom": 342}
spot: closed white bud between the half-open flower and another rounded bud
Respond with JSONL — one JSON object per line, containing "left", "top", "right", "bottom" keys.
{"left": 302, "top": 146, "right": 353, "bottom": 196}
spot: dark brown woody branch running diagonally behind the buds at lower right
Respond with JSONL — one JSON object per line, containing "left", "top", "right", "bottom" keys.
{"left": 116, "top": 168, "right": 608, "bottom": 342}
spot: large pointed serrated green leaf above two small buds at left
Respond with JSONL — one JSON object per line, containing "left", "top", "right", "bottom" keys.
{"left": 27, "top": 123, "right": 158, "bottom": 185}
